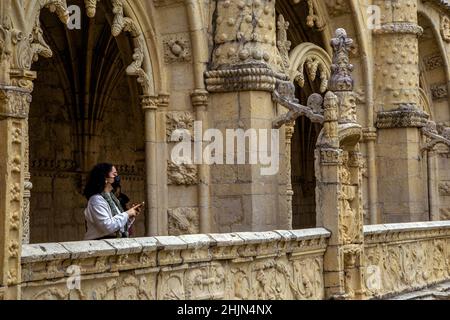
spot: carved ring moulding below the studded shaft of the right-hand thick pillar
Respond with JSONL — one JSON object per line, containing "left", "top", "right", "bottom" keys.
{"left": 377, "top": 104, "right": 429, "bottom": 129}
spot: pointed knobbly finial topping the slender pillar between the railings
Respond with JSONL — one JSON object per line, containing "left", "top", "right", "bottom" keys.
{"left": 329, "top": 28, "right": 353, "bottom": 92}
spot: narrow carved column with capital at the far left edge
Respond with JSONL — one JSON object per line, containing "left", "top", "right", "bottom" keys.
{"left": 0, "top": 85, "right": 31, "bottom": 299}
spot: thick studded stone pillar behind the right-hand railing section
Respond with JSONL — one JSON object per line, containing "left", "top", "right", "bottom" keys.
{"left": 374, "top": 0, "right": 428, "bottom": 222}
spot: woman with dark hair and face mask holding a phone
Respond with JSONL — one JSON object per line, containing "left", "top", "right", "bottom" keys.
{"left": 83, "top": 163, "right": 143, "bottom": 240}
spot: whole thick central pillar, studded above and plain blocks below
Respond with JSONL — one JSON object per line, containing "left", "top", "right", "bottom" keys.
{"left": 206, "top": 0, "right": 287, "bottom": 232}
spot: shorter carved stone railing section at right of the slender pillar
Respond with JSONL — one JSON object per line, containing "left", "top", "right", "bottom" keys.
{"left": 364, "top": 221, "right": 450, "bottom": 298}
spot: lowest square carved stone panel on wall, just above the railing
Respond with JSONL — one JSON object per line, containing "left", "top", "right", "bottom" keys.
{"left": 167, "top": 208, "right": 200, "bottom": 236}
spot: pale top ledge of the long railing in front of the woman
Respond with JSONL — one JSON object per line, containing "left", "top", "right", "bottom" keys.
{"left": 22, "top": 228, "right": 331, "bottom": 281}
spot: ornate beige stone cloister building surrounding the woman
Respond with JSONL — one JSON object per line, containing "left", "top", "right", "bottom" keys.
{"left": 0, "top": 0, "right": 450, "bottom": 300}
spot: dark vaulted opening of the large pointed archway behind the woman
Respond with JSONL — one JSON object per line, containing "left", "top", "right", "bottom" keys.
{"left": 29, "top": 1, "right": 145, "bottom": 243}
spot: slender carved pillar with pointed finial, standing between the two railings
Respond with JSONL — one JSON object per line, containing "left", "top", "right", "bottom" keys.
{"left": 315, "top": 29, "right": 364, "bottom": 299}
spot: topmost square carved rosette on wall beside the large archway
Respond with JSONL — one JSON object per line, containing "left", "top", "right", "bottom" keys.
{"left": 163, "top": 34, "right": 191, "bottom": 63}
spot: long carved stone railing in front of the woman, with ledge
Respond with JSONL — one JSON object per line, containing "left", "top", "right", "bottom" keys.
{"left": 22, "top": 228, "right": 330, "bottom": 299}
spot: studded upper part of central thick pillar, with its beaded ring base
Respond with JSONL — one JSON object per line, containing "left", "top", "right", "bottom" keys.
{"left": 205, "top": 0, "right": 287, "bottom": 92}
